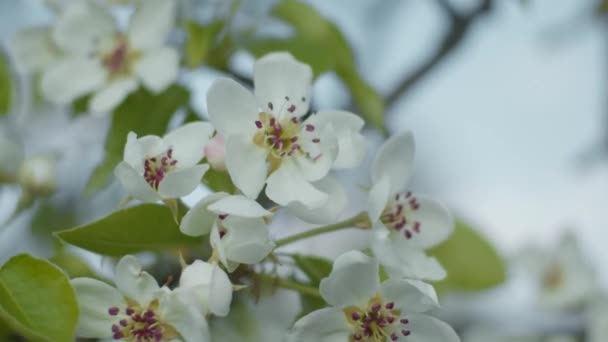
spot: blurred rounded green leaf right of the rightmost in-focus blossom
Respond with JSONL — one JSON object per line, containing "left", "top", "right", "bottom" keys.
{"left": 429, "top": 222, "right": 506, "bottom": 291}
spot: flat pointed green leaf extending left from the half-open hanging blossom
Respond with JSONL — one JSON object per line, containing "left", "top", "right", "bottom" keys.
{"left": 57, "top": 204, "right": 202, "bottom": 256}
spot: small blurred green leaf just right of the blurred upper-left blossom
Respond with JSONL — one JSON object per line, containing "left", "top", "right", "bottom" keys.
{"left": 184, "top": 20, "right": 233, "bottom": 69}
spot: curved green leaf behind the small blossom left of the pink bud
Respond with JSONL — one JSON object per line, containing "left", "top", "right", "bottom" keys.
{"left": 86, "top": 85, "right": 189, "bottom": 193}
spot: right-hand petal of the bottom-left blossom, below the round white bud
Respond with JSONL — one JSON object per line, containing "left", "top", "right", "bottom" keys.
{"left": 159, "top": 293, "right": 211, "bottom": 342}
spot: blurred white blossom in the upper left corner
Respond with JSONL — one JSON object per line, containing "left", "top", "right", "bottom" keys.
{"left": 12, "top": 0, "right": 179, "bottom": 113}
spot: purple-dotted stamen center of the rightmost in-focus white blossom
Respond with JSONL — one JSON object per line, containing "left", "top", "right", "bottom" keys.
{"left": 380, "top": 191, "right": 421, "bottom": 240}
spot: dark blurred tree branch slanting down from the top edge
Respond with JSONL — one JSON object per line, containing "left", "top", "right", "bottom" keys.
{"left": 386, "top": 0, "right": 492, "bottom": 108}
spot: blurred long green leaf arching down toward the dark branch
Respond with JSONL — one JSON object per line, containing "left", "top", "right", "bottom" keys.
{"left": 248, "top": 0, "right": 384, "bottom": 130}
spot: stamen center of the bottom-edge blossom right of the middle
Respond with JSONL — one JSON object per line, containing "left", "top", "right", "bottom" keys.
{"left": 344, "top": 296, "right": 411, "bottom": 342}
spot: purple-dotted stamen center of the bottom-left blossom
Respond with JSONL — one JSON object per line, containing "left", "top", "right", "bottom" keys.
{"left": 108, "top": 301, "right": 178, "bottom": 342}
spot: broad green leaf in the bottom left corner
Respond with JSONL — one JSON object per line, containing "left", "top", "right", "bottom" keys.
{"left": 0, "top": 254, "right": 78, "bottom": 342}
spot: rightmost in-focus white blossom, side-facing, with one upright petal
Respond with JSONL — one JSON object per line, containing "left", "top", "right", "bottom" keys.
{"left": 368, "top": 132, "right": 454, "bottom": 280}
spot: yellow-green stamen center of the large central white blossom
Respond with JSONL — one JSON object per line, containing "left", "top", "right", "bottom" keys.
{"left": 253, "top": 96, "right": 321, "bottom": 173}
